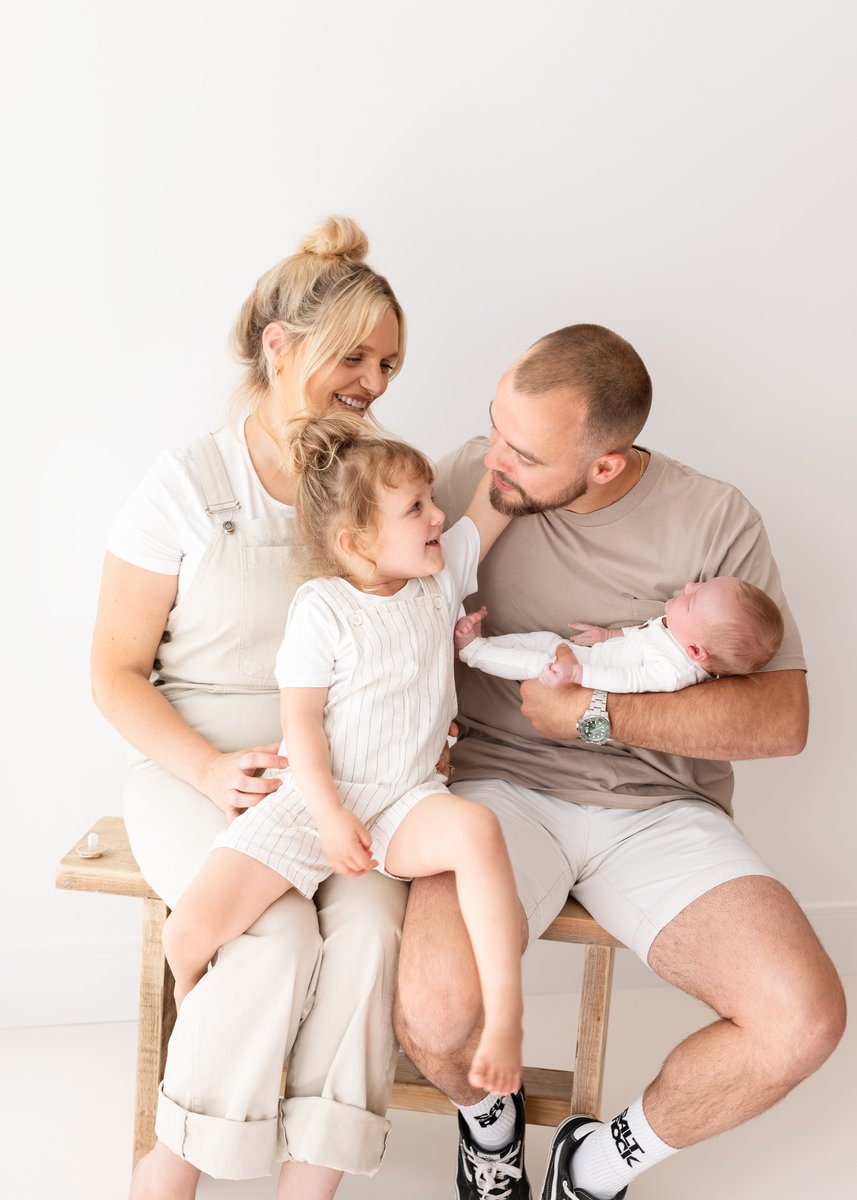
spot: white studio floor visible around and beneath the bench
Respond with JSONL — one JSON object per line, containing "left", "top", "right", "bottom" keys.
{"left": 0, "top": 977, "right": 857, "bottom": 1200}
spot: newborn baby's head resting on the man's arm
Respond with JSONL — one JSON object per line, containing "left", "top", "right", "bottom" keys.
{"left": 666, "top": 575, "right": 783, "bottom": 674}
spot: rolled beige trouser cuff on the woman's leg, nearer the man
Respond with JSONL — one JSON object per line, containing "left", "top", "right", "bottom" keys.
{"left": 278, "top": 1096, "right": 390, "bottom": 1175}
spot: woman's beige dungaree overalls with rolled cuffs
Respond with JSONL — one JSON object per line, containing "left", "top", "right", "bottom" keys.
{"left": 125, "top": 438, "right": 407, "bottom": 1178}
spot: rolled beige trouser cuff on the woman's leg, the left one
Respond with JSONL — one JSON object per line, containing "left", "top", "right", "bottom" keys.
{"left": 155, "top": 1085, "right": 273, "bottom": 1180}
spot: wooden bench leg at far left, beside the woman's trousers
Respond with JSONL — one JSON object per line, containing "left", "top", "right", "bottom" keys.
{"left": 133, "top": 899, "right": 175, "bottom": 1166}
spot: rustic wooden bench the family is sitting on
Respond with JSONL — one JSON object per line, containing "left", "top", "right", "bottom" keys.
{"left": 56, "top": 817, "right": 622, "bottom": 1163}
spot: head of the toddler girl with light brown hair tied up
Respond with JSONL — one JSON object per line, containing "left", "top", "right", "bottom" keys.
{"left": 289, "top": 414, "right": 443, "bottom": 590}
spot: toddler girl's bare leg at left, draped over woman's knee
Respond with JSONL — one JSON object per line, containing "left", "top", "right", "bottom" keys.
{"left": 163, "top": 847, "right": 292, "bottom": 1009}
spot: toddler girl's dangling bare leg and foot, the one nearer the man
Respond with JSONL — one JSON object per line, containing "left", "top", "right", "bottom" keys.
{"left": 386, "top": 794, "right": 523, "bottom": 1093}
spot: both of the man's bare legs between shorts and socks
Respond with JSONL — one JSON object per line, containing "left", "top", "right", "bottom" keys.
{"left": 396, "top": 875, "right": 845, "bottom": 1132}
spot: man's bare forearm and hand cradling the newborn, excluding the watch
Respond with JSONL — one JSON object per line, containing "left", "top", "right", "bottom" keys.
{"left": 521, "top": 650, "right": 809, "bottom": 760}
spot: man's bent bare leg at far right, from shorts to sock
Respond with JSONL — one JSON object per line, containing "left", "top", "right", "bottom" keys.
{"left": 643, "top": 876, "right": 845, "bottom": 1147}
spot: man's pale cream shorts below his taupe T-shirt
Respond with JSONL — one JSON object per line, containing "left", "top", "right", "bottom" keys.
{"left": 450, "top": 779, "right": 773, "bottom": 962}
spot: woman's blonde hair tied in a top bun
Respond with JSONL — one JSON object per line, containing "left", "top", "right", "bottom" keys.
{"left": 225, "top": 216, "right": 406, "bottom": 410}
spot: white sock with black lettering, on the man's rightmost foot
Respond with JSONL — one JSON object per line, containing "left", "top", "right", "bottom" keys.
{"left": 571, "top": 1097, "right": 677, "bottom": 1200}
